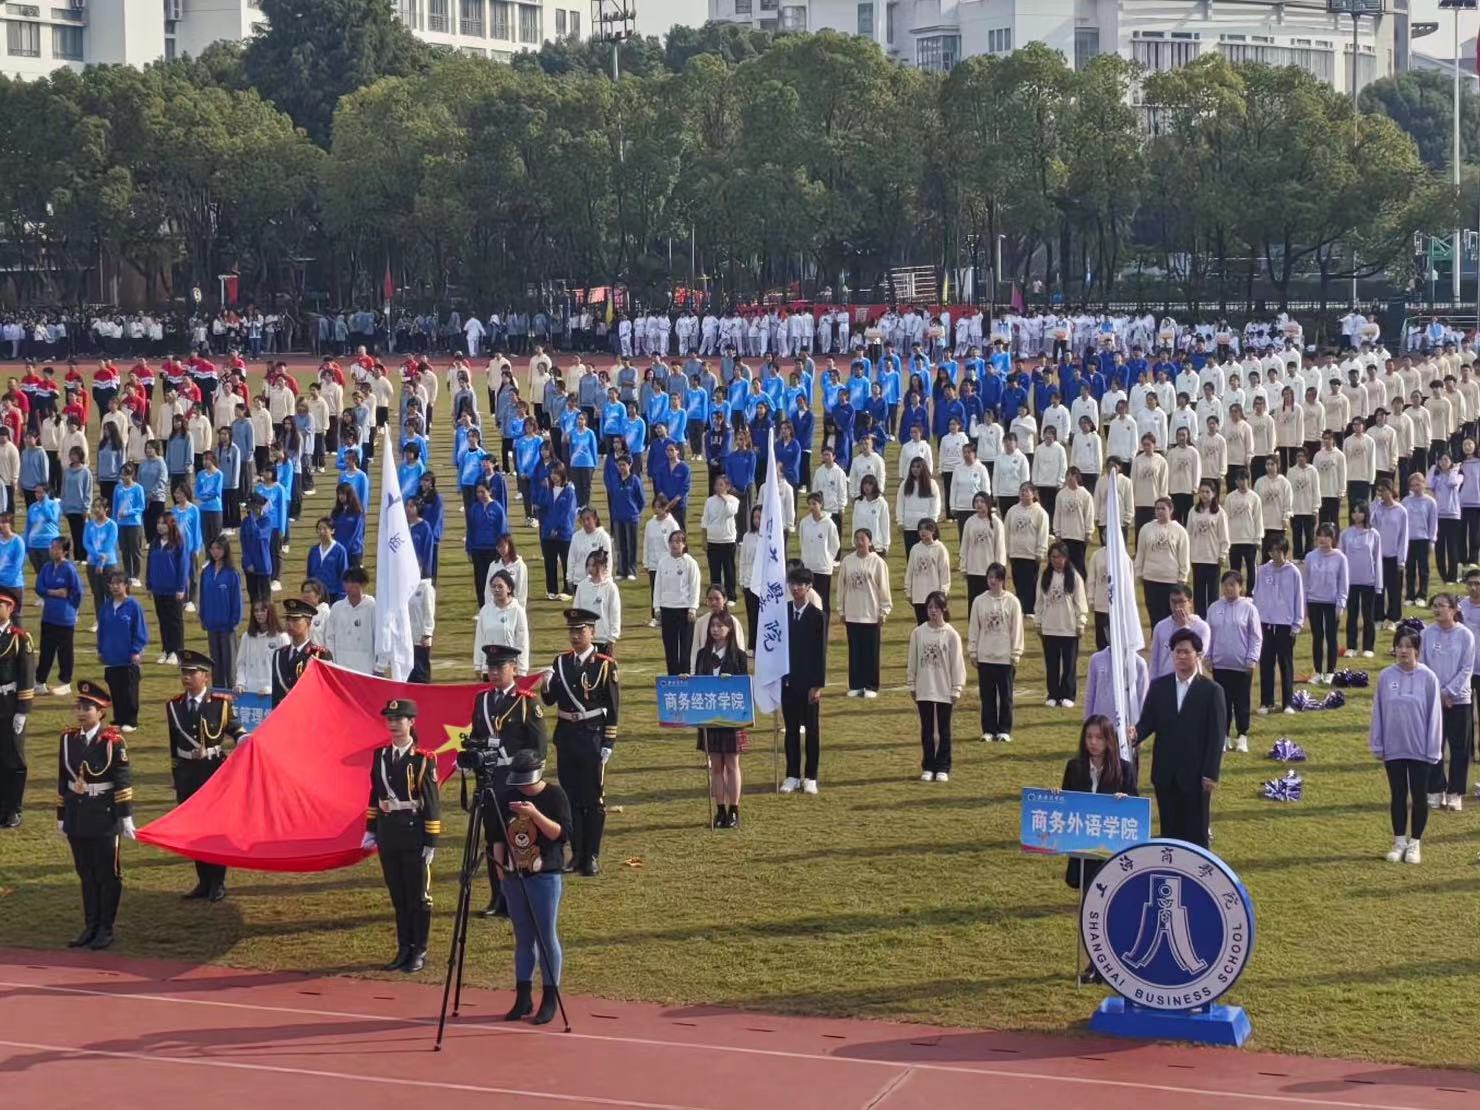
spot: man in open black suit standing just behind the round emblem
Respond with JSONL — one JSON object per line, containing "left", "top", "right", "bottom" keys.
{"left": 1132, "top": 629, "right": 1228, "bottom": 848}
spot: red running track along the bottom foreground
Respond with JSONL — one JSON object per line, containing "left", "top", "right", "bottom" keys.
{"left": 0, "top": 950, "right": 1480, "bottom": 1110}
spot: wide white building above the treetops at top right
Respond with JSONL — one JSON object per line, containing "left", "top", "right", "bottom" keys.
{"left": 709, "top": 0, "right": 1409, "bottom": 92}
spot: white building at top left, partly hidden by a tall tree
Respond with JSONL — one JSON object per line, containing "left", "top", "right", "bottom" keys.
{"left": 0, "top": 0, "right": 591, "bottom": 78}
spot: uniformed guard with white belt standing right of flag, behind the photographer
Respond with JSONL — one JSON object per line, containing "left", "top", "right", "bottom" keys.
{"left": 540, "top": 608, "right": 617, "bottom": 875}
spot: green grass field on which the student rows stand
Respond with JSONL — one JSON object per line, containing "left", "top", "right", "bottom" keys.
{"left": 0, "top": 361, "right": 1480, "bottom": 1067}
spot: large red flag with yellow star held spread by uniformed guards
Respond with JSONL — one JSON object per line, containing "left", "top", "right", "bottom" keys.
{"left": 139, "top": 662, "right": 540, "bottom": 872}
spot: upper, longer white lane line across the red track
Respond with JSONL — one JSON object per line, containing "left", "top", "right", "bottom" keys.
{"left": 0, "top": 980, "right": 1428, "bottom": 1110}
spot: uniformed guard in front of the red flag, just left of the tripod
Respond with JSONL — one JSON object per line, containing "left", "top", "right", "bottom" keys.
{"left": 360, "top": 697, "right": 443, "bottom": 975}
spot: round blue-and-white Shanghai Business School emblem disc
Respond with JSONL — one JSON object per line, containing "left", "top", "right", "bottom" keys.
{"left": 1079, "top": 841, "right": 1254, "bottom": 1009}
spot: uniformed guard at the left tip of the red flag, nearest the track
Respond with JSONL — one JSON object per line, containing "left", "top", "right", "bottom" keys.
{"left": 56, "top": 681, "right": 133, "bottom": 949}
